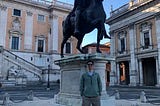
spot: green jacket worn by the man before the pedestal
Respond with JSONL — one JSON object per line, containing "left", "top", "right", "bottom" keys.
{"left": 80, "top": 72, "right": 102, "bottom": 97}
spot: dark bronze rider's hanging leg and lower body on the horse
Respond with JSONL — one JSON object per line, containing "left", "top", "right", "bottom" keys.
{"left": 72, "top": 0, "right": 89, "bottom": 34}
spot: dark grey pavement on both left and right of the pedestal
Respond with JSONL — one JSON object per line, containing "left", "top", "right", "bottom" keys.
{"left": 0, "top": 84, "right": 160, "bottom": 106}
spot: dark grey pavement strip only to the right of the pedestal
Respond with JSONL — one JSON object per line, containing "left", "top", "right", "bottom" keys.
{"left": 107, "top": 86, "right": 160, "bottom": 106}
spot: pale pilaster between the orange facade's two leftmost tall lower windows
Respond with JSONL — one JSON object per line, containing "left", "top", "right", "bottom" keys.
{"left": 24, "top": 11, "right": 33, "bottom": 51}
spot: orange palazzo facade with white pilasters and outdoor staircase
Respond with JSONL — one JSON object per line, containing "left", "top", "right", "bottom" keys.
{"left": 0, "top": 0, "right": 77, "bottom": 84}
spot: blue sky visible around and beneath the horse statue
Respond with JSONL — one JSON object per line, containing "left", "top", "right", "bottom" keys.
{"left": 57, "top": 0, "right": 130, "bottom": 47}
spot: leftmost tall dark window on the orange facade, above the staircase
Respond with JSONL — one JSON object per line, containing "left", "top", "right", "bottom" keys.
{"left": 11, "top": 36, "right": 19, "bottom": 50}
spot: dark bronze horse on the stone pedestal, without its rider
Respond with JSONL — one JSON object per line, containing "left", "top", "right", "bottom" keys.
{"left": 61, "top": 0, "right": 110, "bottom": 57}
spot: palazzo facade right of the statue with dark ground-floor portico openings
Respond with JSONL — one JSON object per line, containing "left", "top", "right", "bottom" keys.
{"left": 106, "top": 0, "right": 160, "bottom": 87}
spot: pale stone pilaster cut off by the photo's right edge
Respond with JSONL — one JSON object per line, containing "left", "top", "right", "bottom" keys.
{"left": 156, "top": 13, "right": 160, "bottom": 87}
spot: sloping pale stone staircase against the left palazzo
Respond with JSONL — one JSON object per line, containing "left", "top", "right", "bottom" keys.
{"left": 1, "top": 49, "right": 42, "bottom": 80}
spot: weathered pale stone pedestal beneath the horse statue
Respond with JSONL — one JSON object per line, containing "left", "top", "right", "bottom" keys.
{"left": 55, "top": 54, "right": 113, "bottom": 106}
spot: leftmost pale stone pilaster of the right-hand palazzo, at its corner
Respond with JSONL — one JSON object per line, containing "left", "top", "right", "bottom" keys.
{"left": 110, "top": 31, "right": 117, "bottom": 86}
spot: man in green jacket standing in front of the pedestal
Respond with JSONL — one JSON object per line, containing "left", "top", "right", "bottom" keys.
{"left": 80, "top": 61, "right": 102, "bottom": 106}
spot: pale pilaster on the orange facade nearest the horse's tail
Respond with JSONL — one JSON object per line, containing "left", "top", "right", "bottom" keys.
{"left": 49, "top": 14, "right": 58, "bottom": 53}
